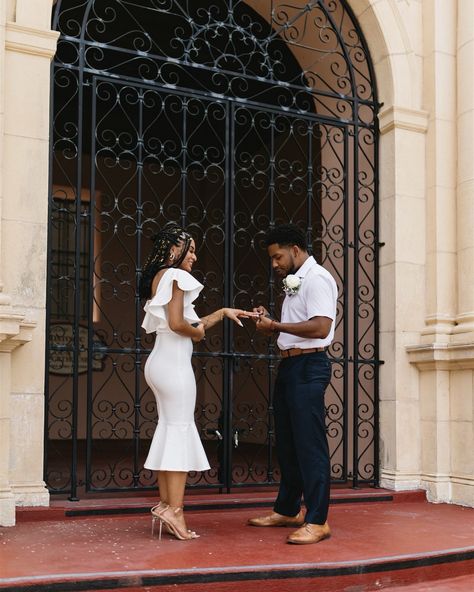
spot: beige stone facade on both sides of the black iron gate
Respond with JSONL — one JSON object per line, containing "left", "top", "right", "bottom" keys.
{"left": 0, "top": 0, "right": 474, "bottom": 524}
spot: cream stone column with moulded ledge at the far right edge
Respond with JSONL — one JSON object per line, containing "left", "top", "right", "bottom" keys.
{"left": 407, "top": 0, "right": 474, "bottom": 505}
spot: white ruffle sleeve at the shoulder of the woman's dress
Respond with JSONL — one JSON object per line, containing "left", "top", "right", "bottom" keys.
{"left": 142, "top": 267, "right": 204, "bottom": 333}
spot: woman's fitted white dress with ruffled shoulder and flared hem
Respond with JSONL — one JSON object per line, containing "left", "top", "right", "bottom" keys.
{"left": 142, "top": 268, "right": 210, "bottom": 471}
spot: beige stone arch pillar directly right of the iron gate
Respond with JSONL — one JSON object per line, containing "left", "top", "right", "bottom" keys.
{"left": 353, "top": 0, "right": 427, "bottom": 489}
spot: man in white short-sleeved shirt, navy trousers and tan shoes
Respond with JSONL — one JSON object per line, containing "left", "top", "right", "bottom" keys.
{"left": 249, "top": 224, "right": 337, "bottom": 544}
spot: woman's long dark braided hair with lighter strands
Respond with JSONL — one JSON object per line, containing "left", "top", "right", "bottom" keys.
{"left": 138, "top": 222, "right": 192, "bottom": 299}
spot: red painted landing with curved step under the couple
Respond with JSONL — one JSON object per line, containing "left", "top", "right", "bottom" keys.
{"left": 0, "top": 490, "right": 474, "bottom": 592}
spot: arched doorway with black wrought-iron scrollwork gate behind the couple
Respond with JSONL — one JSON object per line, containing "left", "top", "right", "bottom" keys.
{"left": 46, "top": 0, "right": 378, "bottom": 498}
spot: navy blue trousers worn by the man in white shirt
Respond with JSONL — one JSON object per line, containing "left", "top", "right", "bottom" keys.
{"left": 273, "top": 352, "right": 331, "bottom": 524}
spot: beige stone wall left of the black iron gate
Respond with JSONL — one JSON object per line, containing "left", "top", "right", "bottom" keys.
{"left": 0, "top": 1, "right": 57, "bottom": 525}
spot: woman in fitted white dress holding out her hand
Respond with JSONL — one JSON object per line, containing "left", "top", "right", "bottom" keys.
{"left": 140, "top": 223, "right": 255, "bottom": 540}
